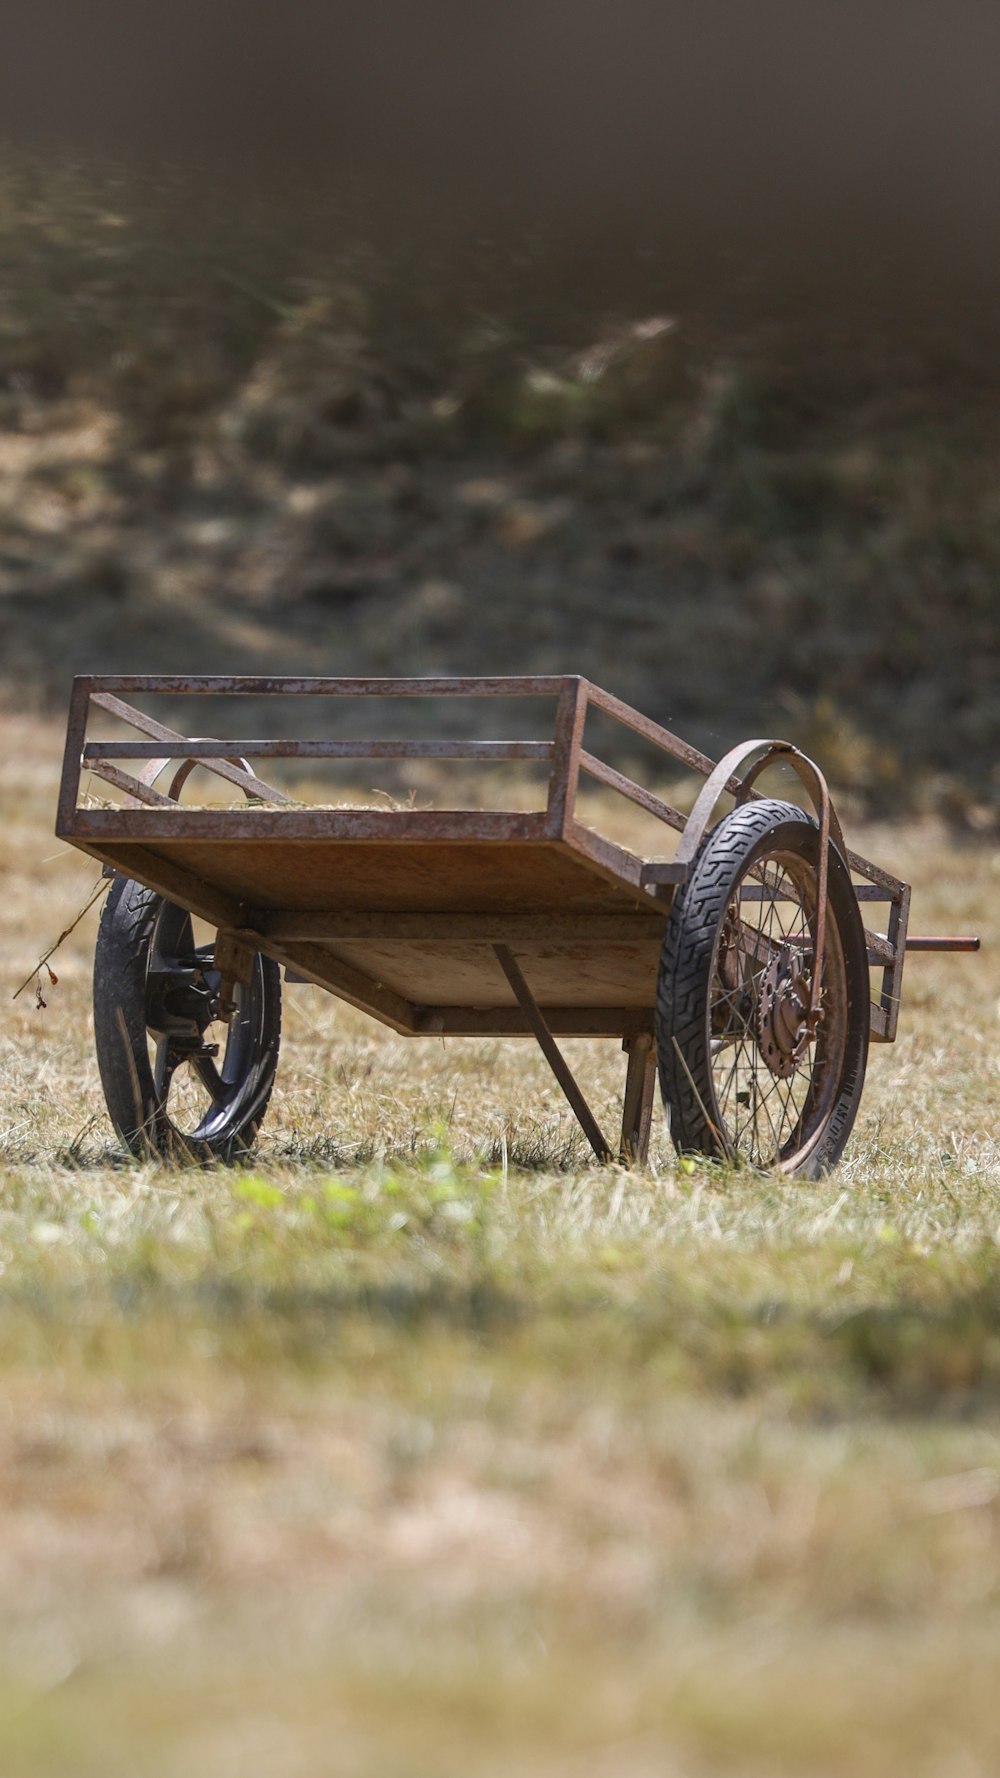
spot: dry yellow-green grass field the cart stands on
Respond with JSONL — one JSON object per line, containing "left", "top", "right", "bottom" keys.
{"left": 0, "top": 717, "right": 1000, "bottom": 1778}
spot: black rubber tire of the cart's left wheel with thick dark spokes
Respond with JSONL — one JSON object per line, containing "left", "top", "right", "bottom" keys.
{"left": 94, "top": 877, "right": 281, "bottom": 1163}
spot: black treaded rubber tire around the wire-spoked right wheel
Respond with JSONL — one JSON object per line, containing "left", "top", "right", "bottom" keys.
{"left": 657, "top": 798, "right": 870, "bottom": 1179}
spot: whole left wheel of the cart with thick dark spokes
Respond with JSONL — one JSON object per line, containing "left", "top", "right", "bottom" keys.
{"left": 94, "top": 877, "right": 281, "bottom": 1161}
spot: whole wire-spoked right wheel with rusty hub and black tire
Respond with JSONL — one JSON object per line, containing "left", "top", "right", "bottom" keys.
{"left": 657, "top": 798, "right": 870, "bottom": 1179}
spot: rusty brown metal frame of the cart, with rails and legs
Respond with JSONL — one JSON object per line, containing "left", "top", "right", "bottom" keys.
{"left": 57, "top": 676, "right": 970, "bottom": 1159}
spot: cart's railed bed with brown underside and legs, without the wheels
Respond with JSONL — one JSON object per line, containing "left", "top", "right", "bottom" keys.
{"left": 57, "top": 676, "right": 909, "bottom": 1152}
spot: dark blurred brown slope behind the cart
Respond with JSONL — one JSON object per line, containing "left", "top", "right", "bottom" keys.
{"left": 0, "top": 0, "right": 1000, "bottom": 814}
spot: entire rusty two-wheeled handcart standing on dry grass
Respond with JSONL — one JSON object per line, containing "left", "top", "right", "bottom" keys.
{"left": 57, "top": 677, "right": 977, "bottom": 1175}
